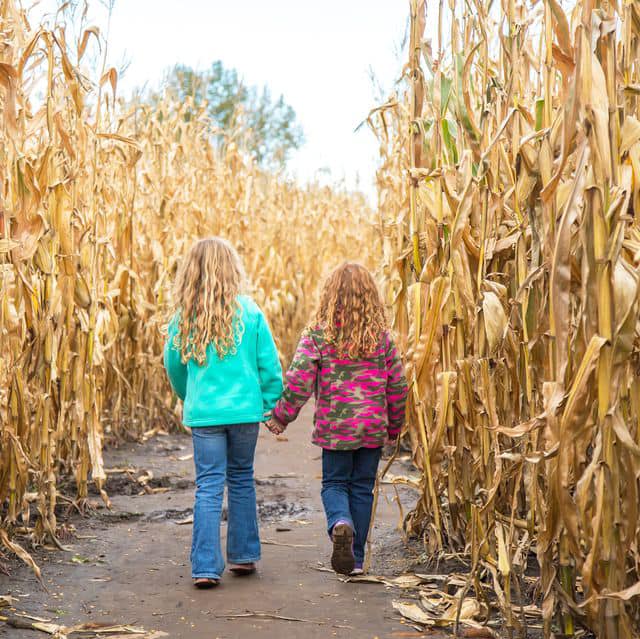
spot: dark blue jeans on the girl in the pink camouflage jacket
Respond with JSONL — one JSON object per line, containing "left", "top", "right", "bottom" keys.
{"left": 322, "top": 448, "right": 382, "bottom": 563}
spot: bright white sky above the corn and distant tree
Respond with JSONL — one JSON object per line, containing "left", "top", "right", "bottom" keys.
{"left": 36, "top": 0, "right": 409, "bottom": 199}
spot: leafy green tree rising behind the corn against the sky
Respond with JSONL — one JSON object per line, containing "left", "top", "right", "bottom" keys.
{"left": 160, "top": 60, "right": 304, "bottom": 168}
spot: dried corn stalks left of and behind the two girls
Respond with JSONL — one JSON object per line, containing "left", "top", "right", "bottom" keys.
{"left": 0, "top": 0, "right": 379, "bottom": 567}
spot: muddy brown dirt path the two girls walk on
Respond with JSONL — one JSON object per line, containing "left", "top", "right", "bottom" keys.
{"left": 0, "top": 409, "right": 444, "bottom": 639}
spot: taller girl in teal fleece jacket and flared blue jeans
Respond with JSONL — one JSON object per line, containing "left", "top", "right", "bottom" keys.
{"left": 164, "top": 237, "right": 282, "bottom": 588}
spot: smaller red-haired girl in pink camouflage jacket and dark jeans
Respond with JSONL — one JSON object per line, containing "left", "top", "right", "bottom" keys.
{"left": 268, "top": 263, "right": 407, "bottom": 574}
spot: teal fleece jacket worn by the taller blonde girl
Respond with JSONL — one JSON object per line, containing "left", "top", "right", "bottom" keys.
{"left": 164, "top": 295, "right": 282, "bottom": 427}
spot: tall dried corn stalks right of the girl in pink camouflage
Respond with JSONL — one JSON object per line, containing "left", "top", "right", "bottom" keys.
{"left": 370, "top": 0, "right": 640, "bottom": 639}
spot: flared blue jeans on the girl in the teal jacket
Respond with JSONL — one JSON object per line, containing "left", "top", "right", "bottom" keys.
{"left": 191, "top": 424, "right": 260, "bottom": 579}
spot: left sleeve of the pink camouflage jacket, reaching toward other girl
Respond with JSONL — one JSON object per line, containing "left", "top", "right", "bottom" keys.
{"left": 273, "top": 331, "right": 320, "bottom": 426}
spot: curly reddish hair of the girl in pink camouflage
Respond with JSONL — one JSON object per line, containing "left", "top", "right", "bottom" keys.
{"left": 315, "top": 262, "right": 388, "bottom": 359}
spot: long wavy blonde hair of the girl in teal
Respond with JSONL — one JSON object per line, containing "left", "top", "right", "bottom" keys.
{"left": 174, "top": 237, "right": 245, "bottom": 365}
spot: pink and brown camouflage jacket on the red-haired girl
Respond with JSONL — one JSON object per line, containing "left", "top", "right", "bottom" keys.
{"left": 273, "top": 328, "right": 407, "bottom": 450}
